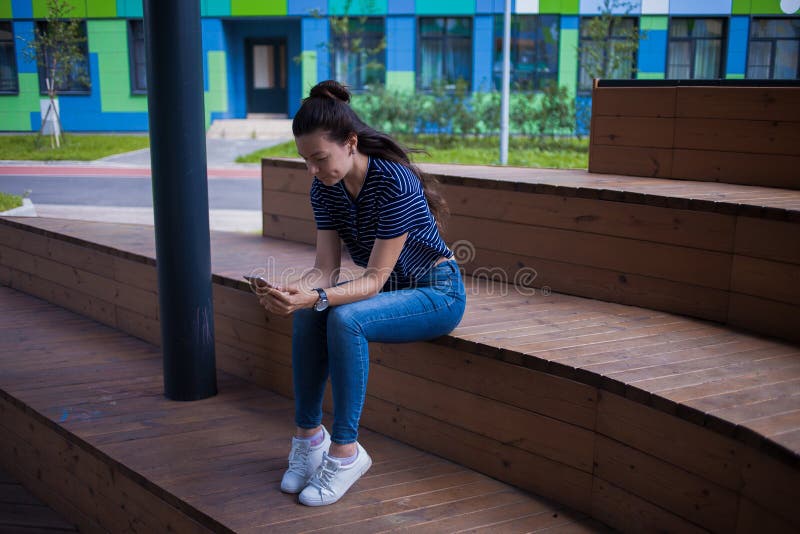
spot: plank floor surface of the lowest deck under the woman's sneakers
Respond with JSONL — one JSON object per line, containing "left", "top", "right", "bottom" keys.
{"left": 0, "top": 286, "right": 603, "bottom": 533}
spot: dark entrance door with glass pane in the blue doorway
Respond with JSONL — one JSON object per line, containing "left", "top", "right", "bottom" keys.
{"left": 245, "top": 39, "right": 288, "bottom": 114}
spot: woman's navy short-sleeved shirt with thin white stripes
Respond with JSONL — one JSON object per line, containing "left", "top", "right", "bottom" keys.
{"left": 310, "top": 157, "right": 453, "bottom": 290}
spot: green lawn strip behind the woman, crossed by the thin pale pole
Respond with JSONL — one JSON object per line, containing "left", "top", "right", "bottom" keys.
{"left": 236, "top": 136, "right": 589, "bottom": 169}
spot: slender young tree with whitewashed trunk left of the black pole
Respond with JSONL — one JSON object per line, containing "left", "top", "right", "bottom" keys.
{"left": 23, "top": 0, "right": 89, "bottom": 147}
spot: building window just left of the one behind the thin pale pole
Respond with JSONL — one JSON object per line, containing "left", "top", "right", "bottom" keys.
{"left": 417, "top": 17, "right": 472, "bottom": 89}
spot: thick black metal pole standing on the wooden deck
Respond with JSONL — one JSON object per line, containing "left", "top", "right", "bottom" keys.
{"left": 144, "top": 0, "right": 217, "bottom": 400}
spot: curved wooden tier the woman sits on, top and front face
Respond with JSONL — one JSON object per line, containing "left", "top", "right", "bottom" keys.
{"left": 0, "top": 219, "right": 800, "bottom": 532}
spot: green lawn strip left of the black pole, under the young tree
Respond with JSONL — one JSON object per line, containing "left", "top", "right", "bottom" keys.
{"left": 0, "top": 134, "right": 150, "bottom": 161}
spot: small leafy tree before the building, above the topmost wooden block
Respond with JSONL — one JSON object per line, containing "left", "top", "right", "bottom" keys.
{"left": 578, "top": 0, "right": 646, "bottom": 89}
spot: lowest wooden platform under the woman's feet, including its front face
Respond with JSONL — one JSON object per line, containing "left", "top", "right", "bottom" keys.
{"left": 0, "top": 287, "right": 604, "bottom": 534}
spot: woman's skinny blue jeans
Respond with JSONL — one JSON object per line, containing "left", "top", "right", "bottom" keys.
{"left": 292, "top": 259, "right": 466, "bottom": 444}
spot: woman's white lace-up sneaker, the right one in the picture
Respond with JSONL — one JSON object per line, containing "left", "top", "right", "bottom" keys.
{"left": 300, "top": 443, "right": 372, "bottom": 506}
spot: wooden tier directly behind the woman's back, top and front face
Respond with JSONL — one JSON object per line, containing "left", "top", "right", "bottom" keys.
{"left": 262, "top": 159, "right": 800, "bottom": 342}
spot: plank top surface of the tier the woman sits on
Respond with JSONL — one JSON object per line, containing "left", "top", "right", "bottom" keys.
{"left": 6, "top": 218, "right": 800, "bottom": 458}
